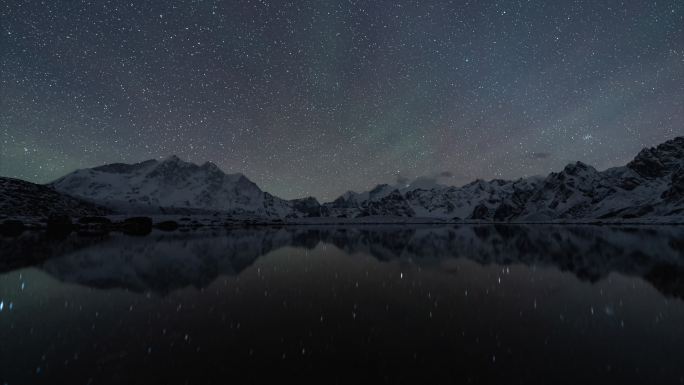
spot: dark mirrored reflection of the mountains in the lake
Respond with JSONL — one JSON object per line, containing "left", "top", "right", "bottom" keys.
{"left": 3, "top": 225, "right": 684, "bottom": 297}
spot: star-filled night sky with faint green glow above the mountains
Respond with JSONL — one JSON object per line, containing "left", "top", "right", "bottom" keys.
{"left": 0, "top": 0, "right": 684, "bottom": 201}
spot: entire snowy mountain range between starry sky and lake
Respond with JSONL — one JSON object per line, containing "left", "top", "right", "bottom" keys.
{"left": 0, "top": 137, "right": 684, "bottom": 222}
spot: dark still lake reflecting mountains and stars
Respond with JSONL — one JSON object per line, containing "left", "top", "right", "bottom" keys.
{"left": 0, "top": 226, "right": 684, "bottom": 384}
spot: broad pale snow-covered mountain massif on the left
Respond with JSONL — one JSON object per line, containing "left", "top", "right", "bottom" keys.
{"left": 50, "top": 156, "right": 308, "bottom": 217}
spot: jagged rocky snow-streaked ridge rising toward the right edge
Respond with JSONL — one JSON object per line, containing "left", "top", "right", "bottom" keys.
{"left": 325, "top": 137, "right": 684, "bottom": 221}
